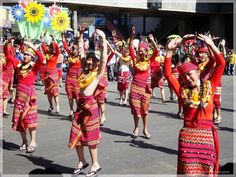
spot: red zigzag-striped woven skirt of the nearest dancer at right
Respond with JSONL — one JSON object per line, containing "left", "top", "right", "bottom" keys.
{"left": 177, "top": 127, "right": 218, "bottom": 176}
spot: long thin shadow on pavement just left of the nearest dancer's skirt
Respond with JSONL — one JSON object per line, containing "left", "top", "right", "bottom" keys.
{"left": 114, "top": 140, "right": 178, "bottom": 155}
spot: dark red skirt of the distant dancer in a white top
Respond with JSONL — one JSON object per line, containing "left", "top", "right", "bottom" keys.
{"left": 117, "top": 71, "right": 130, "bottom": 92}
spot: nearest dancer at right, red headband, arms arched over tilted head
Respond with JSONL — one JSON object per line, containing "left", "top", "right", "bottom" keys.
{"left": 164, "top": 34, "right": 225, "bottom": 176}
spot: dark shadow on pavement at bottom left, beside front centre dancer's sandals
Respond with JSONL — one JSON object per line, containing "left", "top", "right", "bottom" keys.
{"left": 17, "top": 154, "right": 74, "bottom": 174}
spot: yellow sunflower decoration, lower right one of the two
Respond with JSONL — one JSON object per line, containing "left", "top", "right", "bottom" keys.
{"left": 51, "top": 11, "right": 70, "bottom": 32}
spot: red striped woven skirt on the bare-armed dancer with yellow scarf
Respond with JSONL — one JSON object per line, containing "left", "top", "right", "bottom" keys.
{"left": 68, "top": 96, "right": 101, "bottom": 148}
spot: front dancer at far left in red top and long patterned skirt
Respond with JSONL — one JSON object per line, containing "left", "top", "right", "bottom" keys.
{"left": 5, "top": 41, "right": 43, "bottom": 153}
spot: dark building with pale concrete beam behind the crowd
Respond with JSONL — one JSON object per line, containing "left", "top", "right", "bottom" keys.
{"left": 3, "top": 0, "right": 234, "bottom": 48}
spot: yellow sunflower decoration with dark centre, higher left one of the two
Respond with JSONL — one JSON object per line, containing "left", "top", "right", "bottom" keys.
{"left": 25, "top": 1, "right": 44, "bottom": 23}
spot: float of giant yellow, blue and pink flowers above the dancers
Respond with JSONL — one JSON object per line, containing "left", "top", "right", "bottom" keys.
{"left": 11, "top": 0, "right": 71, "bottom": 41}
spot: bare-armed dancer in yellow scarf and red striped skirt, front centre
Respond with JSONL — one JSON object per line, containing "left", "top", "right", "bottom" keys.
{"left": 68, "top": 29, "right": 107, "bottom": 177}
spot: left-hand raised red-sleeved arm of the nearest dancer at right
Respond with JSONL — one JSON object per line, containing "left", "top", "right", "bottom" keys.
{"left": 164, "top": 38, "right": 181, "bottom": 96}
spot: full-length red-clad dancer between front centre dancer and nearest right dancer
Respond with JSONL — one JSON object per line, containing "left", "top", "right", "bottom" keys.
{"left": 129, "top": 27, "right": 159, "bottom": 139}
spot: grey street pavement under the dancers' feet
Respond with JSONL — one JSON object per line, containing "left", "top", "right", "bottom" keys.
{"left": 1, "top": 76, "right": 235, "bottom": 176}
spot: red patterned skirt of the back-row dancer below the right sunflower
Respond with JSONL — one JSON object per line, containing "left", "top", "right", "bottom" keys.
{"left": 44, "top": 70, "right": 59, "bottom": 97}
